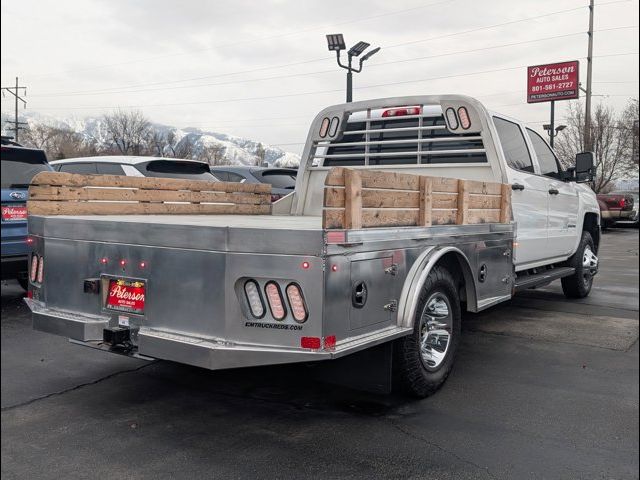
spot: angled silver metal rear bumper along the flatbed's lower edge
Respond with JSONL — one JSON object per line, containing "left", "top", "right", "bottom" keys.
{"left": 25, "top": 298, "right": 412, "bottom": 370}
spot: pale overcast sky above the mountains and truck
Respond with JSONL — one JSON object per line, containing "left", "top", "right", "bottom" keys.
{"left": 1, "top": 0, "right": 639, "bottom": 152}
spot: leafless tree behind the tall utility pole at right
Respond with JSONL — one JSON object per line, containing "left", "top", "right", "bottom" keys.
{"left": 556, "top": 100, "right": 637, "bottom": 193}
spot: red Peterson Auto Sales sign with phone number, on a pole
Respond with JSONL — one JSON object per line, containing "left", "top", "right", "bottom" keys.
{"left": 527, "top": 60, "right": 580, "bottom": 103}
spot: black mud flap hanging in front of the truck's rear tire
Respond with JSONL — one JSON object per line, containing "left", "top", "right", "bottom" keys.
{"left": 311, "top": 342, "right": 393, "bottom": 395}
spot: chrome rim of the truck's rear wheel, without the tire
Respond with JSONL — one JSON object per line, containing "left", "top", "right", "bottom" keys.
{"left": 419, "top": 292, "right": 453, "bottom": 371}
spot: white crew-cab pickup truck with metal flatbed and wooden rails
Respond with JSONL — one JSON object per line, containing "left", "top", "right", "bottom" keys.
{"left": 27, "top": 95, "right": 600, "bottom": 396}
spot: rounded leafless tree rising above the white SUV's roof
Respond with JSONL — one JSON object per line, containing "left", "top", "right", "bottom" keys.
{"left": 104, "top": 110, "right": 152, "bottom": 155}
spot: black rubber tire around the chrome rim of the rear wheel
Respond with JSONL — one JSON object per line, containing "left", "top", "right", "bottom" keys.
{"left": 394, "top": 266, "right": 462, "bottom": 398}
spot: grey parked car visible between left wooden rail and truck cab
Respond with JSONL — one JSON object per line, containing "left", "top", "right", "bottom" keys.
{"left": 211, "top": 166, "right": 298, "bottom": 202}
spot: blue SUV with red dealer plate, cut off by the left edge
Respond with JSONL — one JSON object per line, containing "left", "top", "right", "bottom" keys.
{"left": 0, "top": 138, "right": 51, "bottom": 290}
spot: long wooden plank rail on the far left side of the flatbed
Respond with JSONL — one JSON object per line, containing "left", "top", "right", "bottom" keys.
{"left": 27, "top": 172, "right": 271, "bottom": 215}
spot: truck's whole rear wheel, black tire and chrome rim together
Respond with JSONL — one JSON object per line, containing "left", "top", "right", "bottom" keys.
{"left": 394, "top": 266, "right": 461, "bottom": 398}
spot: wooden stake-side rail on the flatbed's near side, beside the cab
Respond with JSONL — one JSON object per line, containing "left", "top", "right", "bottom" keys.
{"left": 322, "top": 167, "right": 511, "bottom": 229}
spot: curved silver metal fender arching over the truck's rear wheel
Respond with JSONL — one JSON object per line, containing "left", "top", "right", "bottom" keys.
{"left": 397, "top": 247, "right": 476, "bottom": 328}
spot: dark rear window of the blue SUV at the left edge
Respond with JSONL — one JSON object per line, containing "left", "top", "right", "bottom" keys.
{"left": 0, "top": 147, "right": 51, "bottom": 188}
